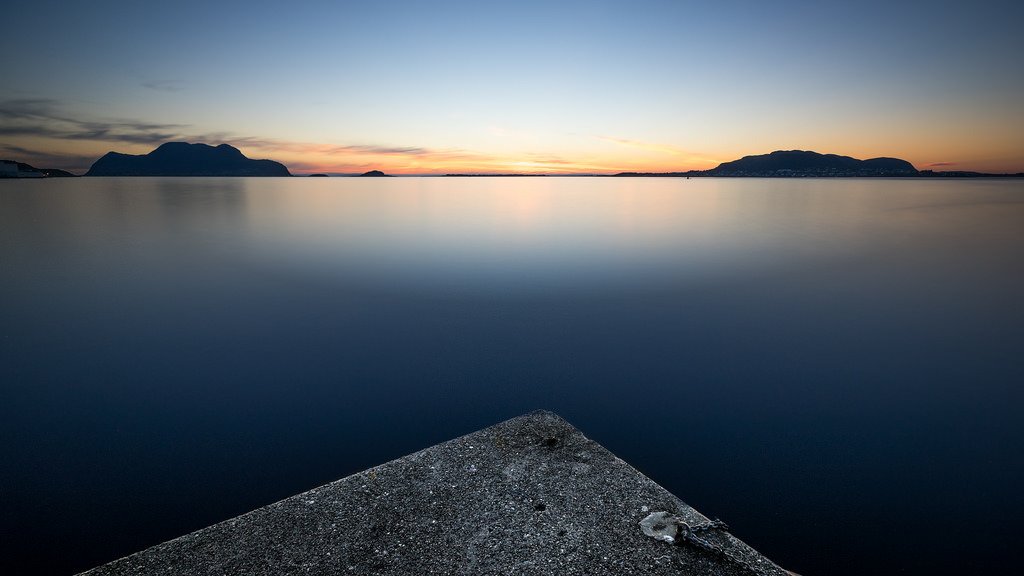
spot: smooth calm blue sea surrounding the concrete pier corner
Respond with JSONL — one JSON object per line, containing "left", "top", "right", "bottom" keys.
{"left": 0, "top": 177, "right": 1024, "bottom": 575}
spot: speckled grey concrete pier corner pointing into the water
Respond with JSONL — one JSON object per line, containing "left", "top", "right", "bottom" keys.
{"left": 84, "top": 411, "right": 786, "bottom": 576}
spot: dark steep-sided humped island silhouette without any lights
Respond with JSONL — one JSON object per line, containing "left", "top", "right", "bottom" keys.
{"left": 85, "top": 142, "right": 292, "bottom": 176}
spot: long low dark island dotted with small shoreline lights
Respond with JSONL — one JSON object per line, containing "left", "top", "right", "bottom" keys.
{"left": 614, "top": 150, "right": 1021, "bottom": 178}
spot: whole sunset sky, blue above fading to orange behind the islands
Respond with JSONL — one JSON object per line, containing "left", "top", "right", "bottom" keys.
{"left": 0, "top": 0, "right": 1024, "bottom": 174}
